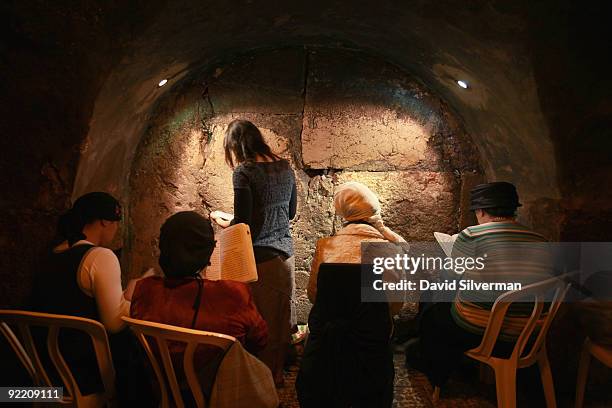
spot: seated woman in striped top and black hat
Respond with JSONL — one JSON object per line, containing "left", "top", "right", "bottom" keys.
{"left": 406, "top": 182, "right": 552, "bottom": 386}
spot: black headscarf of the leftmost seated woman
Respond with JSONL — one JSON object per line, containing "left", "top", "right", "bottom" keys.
{"left": 58, "top": 191, "right": 121, "bottom": 245}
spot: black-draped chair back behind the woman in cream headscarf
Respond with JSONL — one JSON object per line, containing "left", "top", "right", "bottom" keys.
{"left": 298, "top": 263, "right": 393, "bottom": 406}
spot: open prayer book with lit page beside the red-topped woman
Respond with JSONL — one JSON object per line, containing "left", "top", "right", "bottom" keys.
{"left": 206, "top": 224, "right": 257, "bottom": 282}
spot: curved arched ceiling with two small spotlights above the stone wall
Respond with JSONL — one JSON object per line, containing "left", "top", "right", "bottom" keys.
{"left": 73, "top": 0, "right": 559, "bottom": 202}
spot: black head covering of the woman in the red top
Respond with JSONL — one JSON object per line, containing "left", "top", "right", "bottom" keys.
{"left": 159, "top": 211, "right": 215, "bottom": 278}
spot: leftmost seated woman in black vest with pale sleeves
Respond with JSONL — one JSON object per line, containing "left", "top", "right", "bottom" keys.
{"left": 31, "top": 192, "right": 151, "bottom": 406}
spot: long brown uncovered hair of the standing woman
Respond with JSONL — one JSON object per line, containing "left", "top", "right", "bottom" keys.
{"left": 223, "top": 119, "right": 280, "bottom": 168}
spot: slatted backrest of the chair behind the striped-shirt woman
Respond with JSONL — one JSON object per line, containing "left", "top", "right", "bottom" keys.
{"left": 472, "top": 276, "right": 570, "bottom": 366}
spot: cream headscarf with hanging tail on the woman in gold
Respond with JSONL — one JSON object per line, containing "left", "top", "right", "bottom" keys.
{"left": 334, "top": 181, "right": 406, "bottom": 242}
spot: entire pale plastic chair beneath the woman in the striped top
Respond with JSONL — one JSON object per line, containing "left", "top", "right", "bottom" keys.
{"left": 433, "top": 277, "right": 570, "bottom": 408}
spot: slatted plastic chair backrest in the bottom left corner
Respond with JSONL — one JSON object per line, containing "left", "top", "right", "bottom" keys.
{"left": 0, "top": 310, "right": 115, "bottom": 406}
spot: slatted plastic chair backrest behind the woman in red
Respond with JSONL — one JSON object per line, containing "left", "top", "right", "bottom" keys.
{"left": 123, "top": 317, "right": 236, "bottom": 407}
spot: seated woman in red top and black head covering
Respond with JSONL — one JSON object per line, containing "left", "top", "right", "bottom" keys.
{"left": 130, "top": 211, "right": 268, "bottom": 397}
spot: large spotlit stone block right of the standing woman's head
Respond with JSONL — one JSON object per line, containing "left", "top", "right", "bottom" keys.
{"left": 302, "top": 51, "right": 441, "bottom": 171}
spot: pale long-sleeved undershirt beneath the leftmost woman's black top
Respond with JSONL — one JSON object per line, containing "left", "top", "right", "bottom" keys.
{"left": 54, "top": 240, "right": 130, "bottom": 333}
